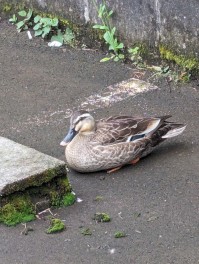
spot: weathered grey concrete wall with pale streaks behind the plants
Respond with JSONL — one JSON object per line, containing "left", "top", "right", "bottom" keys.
{"left": 0, "top": 0, "right": 199, "bottom": 59}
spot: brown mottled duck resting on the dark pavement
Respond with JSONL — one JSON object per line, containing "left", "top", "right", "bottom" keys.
{"left": 60, "top": 110, "right": 186, "bottom": 173}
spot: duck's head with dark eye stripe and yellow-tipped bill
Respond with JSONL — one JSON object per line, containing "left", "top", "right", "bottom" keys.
{"left": 60, "top": 110, "right": 95, "bottom": 146}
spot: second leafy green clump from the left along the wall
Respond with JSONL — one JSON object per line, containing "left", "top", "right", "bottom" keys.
{"left": 33, "top": 15, "right": 59, "bottom": 38}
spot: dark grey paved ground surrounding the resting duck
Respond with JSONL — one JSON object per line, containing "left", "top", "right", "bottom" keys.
{"left": 0, "top": 22, "right": 199, "bottom": 264}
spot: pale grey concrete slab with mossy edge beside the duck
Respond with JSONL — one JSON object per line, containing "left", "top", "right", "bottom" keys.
{"left": 0, "top": 137, "right": 66, "bottom": 196}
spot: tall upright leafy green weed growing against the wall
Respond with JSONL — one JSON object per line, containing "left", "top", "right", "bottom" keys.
{"left": 93, "top": 0, "right": 124, "bottom": 62}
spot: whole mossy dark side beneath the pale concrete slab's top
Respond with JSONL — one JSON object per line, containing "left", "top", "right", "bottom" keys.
{"left": 0, "top": 176, "right": 76, "bottom": 226}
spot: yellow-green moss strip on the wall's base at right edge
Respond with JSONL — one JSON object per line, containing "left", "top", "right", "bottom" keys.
{"left": 159, "top": 45, "right": 199, "bottom": 71}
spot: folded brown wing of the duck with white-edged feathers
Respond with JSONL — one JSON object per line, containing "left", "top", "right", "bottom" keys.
{"left": 94, "top": 116, "right": 170, "bottom": 145}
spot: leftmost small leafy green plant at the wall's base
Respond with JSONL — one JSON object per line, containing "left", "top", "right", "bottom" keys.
{"left": 15, "top": 9, "right": 32, "bottom": 32}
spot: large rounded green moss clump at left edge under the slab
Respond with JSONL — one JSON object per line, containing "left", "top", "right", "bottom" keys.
{"left": 0, "top": 194, "right": 35, "bottom": 226}
